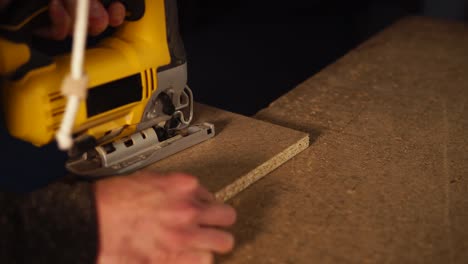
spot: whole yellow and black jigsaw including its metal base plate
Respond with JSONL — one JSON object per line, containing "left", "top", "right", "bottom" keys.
{"left": 0, "top": 0, "right": 215, "bottom": 177}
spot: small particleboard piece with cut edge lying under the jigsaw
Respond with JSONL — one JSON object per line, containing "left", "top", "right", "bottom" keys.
{"left": 144, "top": 104, "right": 309, "bottom": 201}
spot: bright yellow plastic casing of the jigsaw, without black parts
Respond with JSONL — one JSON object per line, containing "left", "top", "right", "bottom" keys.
{"left": 2, "top": 0, "right": 170, "bottom": 146}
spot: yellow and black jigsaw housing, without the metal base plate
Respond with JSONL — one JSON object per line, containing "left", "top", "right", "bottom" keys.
{"left": 0, "top": 0, "right": 185, "bottom": 146}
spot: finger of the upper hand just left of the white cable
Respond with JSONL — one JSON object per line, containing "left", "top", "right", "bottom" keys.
{"left": 36, "top": 0, "right": 72, "bottom": 40}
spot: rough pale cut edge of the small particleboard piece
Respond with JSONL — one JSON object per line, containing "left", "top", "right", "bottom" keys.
{"left": 215, "top": 134, "right": 310, "bottom": 202}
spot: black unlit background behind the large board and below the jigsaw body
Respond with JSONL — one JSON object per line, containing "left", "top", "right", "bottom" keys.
{"left": 0, "top": 0, "right": 467, "bottom": 191}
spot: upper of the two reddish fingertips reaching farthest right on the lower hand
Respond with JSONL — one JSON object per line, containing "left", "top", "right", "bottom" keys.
{"left": 198, "top": 204, "right": 237, "bottom": 227}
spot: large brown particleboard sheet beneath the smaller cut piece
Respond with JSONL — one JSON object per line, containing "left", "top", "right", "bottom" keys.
{"left": 219, "top": 18, "right": 468, "bottom": 264}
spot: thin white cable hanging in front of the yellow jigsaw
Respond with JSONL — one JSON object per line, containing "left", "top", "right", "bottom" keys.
{"left": 56, "top": 0, "right": 89, "bottom": 150}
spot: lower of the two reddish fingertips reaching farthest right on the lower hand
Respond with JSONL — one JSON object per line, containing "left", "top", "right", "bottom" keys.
{"left": 191, "top": 228, "right": 234, "bottom": 254}
